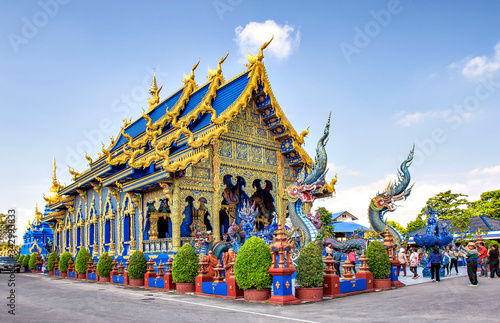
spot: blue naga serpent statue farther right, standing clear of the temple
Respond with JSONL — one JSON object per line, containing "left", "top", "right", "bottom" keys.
{"left": 368, "top": 146, "right": 415, "bottom": 246}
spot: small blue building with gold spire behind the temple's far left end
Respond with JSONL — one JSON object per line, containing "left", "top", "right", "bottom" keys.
{"left": 20, "top": 205, "right": 54, "bottom": 256}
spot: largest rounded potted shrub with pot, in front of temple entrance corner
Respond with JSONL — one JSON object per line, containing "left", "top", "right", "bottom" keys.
{"left": 234, "top": 237, "right": 273, "bottom": 302}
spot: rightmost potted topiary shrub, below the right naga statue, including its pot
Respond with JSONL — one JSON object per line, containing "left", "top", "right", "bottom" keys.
{"left": 366, "top": 241, "right": 391, "bottom": 289}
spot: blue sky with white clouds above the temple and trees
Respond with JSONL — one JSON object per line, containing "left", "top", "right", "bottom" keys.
{"left": 0, "top": 0, "right": 500, "bottom": 238}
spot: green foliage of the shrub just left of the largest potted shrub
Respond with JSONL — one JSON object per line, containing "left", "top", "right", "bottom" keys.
{"left": 172, "top": 243, "right": 199, "bottom": 283}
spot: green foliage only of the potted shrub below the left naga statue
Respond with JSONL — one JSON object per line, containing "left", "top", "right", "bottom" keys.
{"left": 295, "top": 241, "right": 323, "bottom": 288}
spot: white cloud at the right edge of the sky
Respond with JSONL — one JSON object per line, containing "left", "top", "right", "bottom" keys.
{"left": 448, "top": 42, "right": 500, "bottom": 78}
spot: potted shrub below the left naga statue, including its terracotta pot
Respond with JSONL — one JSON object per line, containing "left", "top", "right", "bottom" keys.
{"left": 295, "top": 241, "right": 323, "bottom": 302}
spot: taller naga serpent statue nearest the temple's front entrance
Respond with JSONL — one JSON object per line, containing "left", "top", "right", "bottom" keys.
{"left": 286, "top": 116, "right": 330, "bottom": 243}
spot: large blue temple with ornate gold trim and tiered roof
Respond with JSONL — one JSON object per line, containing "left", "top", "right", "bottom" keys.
{"left": 41, "top": 49, "right": 333, "bottom": 260}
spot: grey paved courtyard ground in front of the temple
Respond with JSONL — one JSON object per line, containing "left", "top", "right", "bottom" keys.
{"left": 0, "top": 273, "right": 500, "bottom": 323}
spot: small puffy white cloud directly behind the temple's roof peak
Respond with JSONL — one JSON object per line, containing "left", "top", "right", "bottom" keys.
{"left": 234, "top": 20, "right": 300, "bottom": 59}
